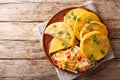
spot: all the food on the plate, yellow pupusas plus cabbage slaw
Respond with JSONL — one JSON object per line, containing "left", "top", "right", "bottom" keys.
{"left": 45, "top": 8, "right": 109, "bottom": 73}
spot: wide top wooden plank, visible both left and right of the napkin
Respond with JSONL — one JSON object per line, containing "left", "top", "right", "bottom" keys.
{"left": 0, "top": 0, "right": 120, "bottom": 21}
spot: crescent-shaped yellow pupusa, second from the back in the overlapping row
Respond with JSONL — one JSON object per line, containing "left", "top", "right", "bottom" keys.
{"left": 74, "top": 12, "right": 100, "bottom": 40}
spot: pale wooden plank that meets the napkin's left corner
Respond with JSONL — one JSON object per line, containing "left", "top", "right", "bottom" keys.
{"left": 0, "top": 22, "right": 40, "bottom": 40}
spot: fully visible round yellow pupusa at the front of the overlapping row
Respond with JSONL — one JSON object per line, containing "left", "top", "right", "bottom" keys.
{"left": 80, "top": 31, "right": 110, "bottom": 61}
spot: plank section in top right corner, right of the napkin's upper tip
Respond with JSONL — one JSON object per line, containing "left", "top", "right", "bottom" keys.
{"left": 95, "top": 0, "right": 120, "bottom": 21}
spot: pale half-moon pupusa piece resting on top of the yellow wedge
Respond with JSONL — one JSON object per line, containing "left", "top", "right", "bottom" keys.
{"left": 45, "top": 22, "right": 75, "bottom": 45}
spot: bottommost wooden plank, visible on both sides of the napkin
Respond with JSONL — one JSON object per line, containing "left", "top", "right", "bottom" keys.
{"left": 0, "top": 59, "right": 120, "bottom": 80}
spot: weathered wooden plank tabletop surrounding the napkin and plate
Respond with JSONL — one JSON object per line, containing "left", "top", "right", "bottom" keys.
{"left": 0, "top": 0, "right": 120, "bottom": 80}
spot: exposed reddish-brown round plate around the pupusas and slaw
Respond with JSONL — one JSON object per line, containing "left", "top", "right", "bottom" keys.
{"left": 43, "top": 7, "right": 108, "bottom": 74}
